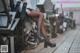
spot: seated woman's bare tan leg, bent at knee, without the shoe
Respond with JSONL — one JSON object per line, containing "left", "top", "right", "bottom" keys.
{"left": 28, "top": 11, "right": 47, "bottom": 39}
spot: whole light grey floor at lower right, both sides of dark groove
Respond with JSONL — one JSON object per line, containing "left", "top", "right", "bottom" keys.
{"left": 53, "top": 27, "right": 80, "bottom": 53}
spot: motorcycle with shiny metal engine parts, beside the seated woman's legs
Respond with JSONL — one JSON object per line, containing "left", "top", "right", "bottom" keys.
{"left": 19, "top": 3, "right": 44, "bottom": 49}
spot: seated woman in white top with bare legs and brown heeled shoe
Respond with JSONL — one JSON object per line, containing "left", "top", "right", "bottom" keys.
{"left": 20, "top": 0, "right": 56, "bottom": 47}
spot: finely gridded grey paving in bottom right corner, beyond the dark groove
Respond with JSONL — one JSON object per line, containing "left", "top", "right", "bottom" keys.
{"left": 69, "top": 31, "right": 80, "bottom": 53}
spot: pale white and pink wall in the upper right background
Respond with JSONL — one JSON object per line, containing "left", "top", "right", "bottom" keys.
{"left": 52, "top": 0, "right": 80, "bottom": 24}
